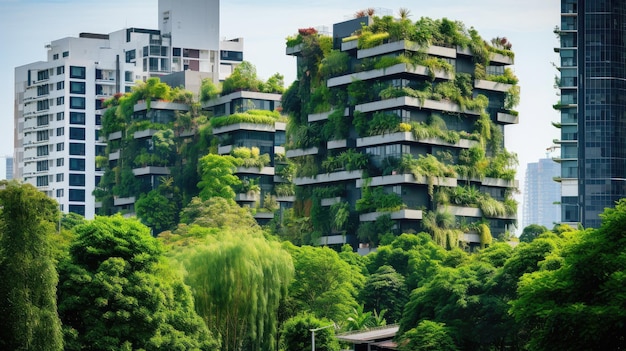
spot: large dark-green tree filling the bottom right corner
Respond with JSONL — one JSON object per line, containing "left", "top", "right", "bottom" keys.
{"left": 511, "top": 199, "right": 626, "bottom": 350}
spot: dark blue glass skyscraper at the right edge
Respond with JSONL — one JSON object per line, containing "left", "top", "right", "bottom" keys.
{"left": 555, "top": 0, "right": 626, "bottom": 228}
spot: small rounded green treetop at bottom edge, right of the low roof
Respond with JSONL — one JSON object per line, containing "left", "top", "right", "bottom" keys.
{"left": 398, "top": 320, "right": 458, "bottom": 351}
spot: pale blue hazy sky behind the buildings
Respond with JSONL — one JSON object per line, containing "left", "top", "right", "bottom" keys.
{"left": 0, "top": 0, "right": 560, "bottom": 230}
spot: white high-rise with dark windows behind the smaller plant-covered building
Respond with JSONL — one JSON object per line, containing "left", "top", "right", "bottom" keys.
{"left": 14, "top": 0, "right": 243, "bottom": 218}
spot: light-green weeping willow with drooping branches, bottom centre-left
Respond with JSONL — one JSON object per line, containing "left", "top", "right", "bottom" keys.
{"left": 185, "top": 233, "right": 293, "bottom": 351}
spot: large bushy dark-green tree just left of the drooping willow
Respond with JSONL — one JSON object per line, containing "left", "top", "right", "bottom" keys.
{"left": 59, "top": 215, "right": 218, "bottom": 351}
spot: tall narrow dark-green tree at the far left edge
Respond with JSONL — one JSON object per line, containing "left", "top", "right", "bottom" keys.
{"left": 0, "top": 181, "right": 63, "bottom": 350}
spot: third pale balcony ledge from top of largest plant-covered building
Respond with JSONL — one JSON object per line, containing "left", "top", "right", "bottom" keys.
{"left": 355, "top": 96, "right": 480, "bottom": 116}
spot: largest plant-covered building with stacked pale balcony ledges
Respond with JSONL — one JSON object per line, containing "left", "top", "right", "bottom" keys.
{"left": 283, "top": 13, "right": 519, "bottom": 248}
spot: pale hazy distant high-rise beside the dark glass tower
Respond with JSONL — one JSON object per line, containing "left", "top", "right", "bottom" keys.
{"left": 522, "top": 158, "right": 561, "bottom": 228}
